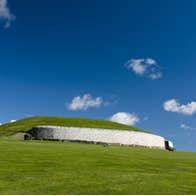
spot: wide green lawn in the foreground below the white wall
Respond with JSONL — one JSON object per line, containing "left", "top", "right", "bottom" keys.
{"left": 0, "top": 138, "right": 196, "bottom": 194}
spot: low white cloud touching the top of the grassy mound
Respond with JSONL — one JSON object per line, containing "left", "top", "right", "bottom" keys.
{"left": 109, "top": 112, "right": 140, "bottom": 125}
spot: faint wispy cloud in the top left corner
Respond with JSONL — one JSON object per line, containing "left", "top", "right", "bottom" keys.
{"left": 0, "top": 0, "right": 15, "bottom": 28}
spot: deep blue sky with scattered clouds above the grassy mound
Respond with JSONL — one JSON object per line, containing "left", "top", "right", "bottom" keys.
{"left": 0, "top": 0, "right": 196, "bottom": 151}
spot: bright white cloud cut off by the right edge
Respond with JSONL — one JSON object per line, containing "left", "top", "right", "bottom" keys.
{"left": 163, "top": 99, "right": 196, "bottom": 115}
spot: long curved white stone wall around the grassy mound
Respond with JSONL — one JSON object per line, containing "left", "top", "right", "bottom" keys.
{"left": 31, "top": 126, "right": 165, "bottom": 149}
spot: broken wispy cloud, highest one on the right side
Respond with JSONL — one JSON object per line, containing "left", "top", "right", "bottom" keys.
{"left": 125, "top": 58, "right": 162, "bottom": 80}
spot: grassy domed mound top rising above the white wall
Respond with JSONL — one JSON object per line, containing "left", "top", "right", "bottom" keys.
{"left": 0, "top": 116, "right": 149, "bottom": 136}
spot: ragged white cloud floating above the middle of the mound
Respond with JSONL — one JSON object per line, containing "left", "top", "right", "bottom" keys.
{"left": 68, "top": 94, "right": 103, "bottom": 111}
